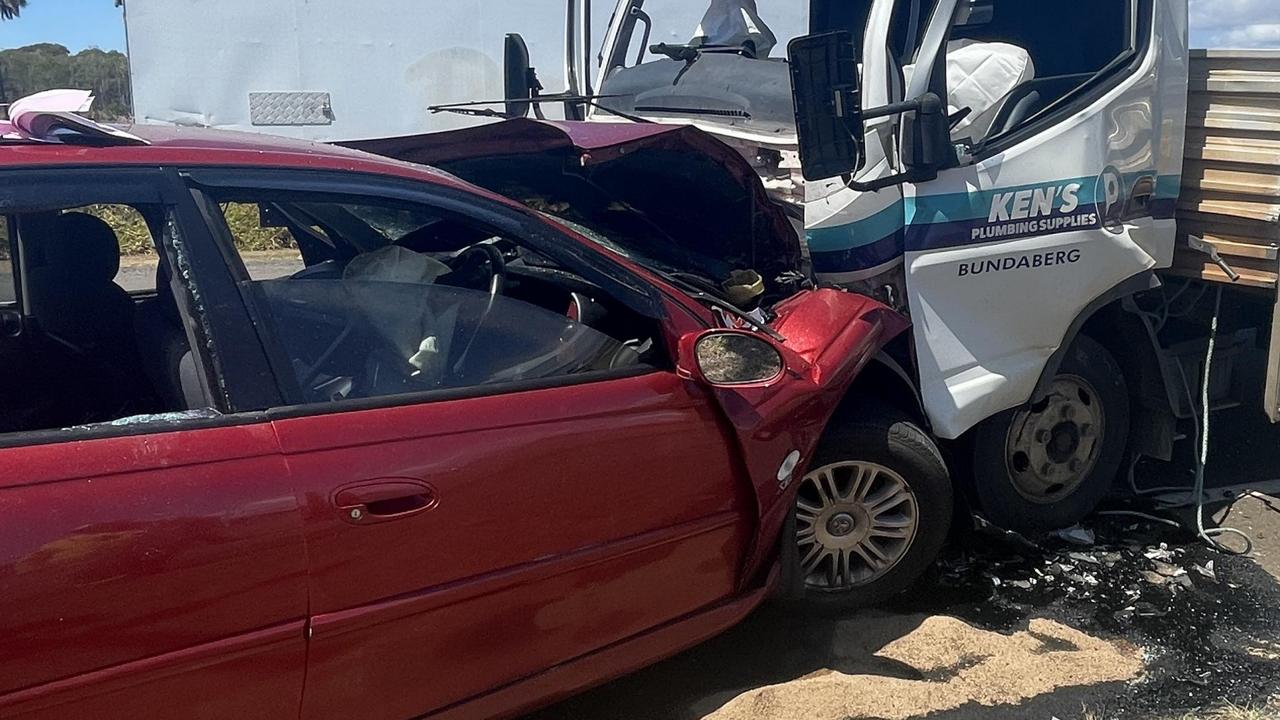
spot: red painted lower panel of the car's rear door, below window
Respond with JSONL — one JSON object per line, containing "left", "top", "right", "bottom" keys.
{"left": 0, "top": 424, "right": 307, "bottom": 717}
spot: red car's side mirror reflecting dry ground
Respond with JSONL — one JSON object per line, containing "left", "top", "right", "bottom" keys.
{"left": 678, "top": 331, "right": 786, "bottom": 387}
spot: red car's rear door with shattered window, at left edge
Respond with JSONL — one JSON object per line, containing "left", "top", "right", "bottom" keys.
{"left": 0, "top": 169, "right": 306, "bottom": 720}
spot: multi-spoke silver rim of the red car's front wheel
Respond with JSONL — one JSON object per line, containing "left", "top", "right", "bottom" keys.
{"left": 796, "top": 461, "right": 920, "bottom": 592}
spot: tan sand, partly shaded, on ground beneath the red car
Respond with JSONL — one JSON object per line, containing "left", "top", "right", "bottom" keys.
{"left": 529, "top": 607, "right": 1144, "bottom": 720}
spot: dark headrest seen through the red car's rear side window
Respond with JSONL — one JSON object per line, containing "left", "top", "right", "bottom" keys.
{"left": 36, "top": 213, "right": 120, "bottom": 283}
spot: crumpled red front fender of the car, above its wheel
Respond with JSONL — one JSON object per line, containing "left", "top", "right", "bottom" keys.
{"left": 691, "top": 290, "right": 910, "bottom": 585}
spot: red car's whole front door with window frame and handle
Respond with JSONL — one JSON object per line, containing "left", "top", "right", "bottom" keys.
{"left": 192, "top": 170, "right": 754, "bottom": 719}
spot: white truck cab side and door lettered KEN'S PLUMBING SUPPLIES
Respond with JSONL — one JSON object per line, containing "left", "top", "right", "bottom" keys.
{"left": 890, "top": 0, "right": 1188, "bottom": 438}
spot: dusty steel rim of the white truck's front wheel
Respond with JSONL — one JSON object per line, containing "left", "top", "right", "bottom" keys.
{"left": 1005, "top": 375, "right": 1106, "bottom": 505}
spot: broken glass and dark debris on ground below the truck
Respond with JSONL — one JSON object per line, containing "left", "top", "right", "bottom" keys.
{"left": 921, "top": 520, "right": 1280, "bottom": 717}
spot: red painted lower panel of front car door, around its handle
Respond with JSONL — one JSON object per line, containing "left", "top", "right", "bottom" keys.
{"left": 275, "top": 372, "right": 754, "bottom": 719}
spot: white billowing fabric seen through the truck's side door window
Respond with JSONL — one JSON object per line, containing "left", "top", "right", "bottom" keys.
{"left": 902, "top": 40, "right": 1036, "bottom": 141}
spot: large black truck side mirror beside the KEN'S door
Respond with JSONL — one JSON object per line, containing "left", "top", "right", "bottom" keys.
{"left": 787, "top": 31, "right": 865, "bottom": 181}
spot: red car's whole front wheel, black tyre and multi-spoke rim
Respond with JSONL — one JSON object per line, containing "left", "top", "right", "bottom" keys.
{"left": 782, "top": 409, "right": 955, "bottom": 612}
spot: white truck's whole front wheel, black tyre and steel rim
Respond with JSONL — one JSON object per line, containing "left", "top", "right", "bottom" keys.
{"left": 973, "top": 336, "right": 1129, "bottom": 532}
